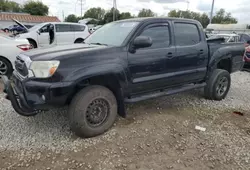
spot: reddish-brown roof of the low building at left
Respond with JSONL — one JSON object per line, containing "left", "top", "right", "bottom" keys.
{"left": 0, "top": 12, "right": 60, "bottom": 23}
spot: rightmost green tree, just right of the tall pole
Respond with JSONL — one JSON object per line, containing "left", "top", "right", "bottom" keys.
{"left": 212, "top": 9, "right": 238, "bottom": 24}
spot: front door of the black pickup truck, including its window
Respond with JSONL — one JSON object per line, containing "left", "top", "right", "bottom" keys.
{"left": 128, "top": 22, "right": 175, "bottom": 94}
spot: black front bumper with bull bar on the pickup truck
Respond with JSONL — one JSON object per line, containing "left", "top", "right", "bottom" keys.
{"left": 2, "top": 71, "right": 75, "bottom": 116}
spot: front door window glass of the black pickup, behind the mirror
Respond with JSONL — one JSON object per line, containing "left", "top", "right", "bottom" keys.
{"left": 138, "top": 25, "right": 170, "bottom": 49}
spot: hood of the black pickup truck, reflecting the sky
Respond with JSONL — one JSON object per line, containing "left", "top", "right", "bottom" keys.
{"left": 24, "top": 44, "right": 112, "bottom": 61}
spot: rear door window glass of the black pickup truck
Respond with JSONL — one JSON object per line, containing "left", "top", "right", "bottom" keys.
{"left": 174, "top": 23, "right": 201, "bottom": 46}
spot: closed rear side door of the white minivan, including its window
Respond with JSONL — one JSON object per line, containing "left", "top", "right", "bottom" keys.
{"left": 55, "top": 24, "right": 75, "bottom": 45}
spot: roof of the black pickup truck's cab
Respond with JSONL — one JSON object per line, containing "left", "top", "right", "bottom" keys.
{"left": 116, "top": 17, "right": 198, "bottom": 23}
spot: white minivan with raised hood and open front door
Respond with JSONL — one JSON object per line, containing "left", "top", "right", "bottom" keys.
{"left": 13, "top": 19, "right": 90, "bottom": 48}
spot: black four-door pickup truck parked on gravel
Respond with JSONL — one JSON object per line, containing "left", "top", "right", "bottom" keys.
{"left": 3, "top": 18, "right": 245, "bottom": 137}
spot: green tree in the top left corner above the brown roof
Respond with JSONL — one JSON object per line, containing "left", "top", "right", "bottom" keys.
{"left": 0, "top": 0, "right": 22, "bottom": 12}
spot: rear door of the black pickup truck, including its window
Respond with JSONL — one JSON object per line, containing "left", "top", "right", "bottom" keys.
{"left": 173, "top": 22, "right": 208, "bottom": 84}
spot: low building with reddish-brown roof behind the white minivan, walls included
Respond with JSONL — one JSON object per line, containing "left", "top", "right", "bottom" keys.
{"left": 0, "top": 12, "right": 60, "bottom": 28}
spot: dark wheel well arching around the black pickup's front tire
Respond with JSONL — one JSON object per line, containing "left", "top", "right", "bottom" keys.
{"left": 68, "top": 75, "right": 126, "bottom": 117}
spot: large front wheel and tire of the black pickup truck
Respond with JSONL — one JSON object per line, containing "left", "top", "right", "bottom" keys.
{"left": 69, "top": 86, "right": 117, "bottom": 138}
